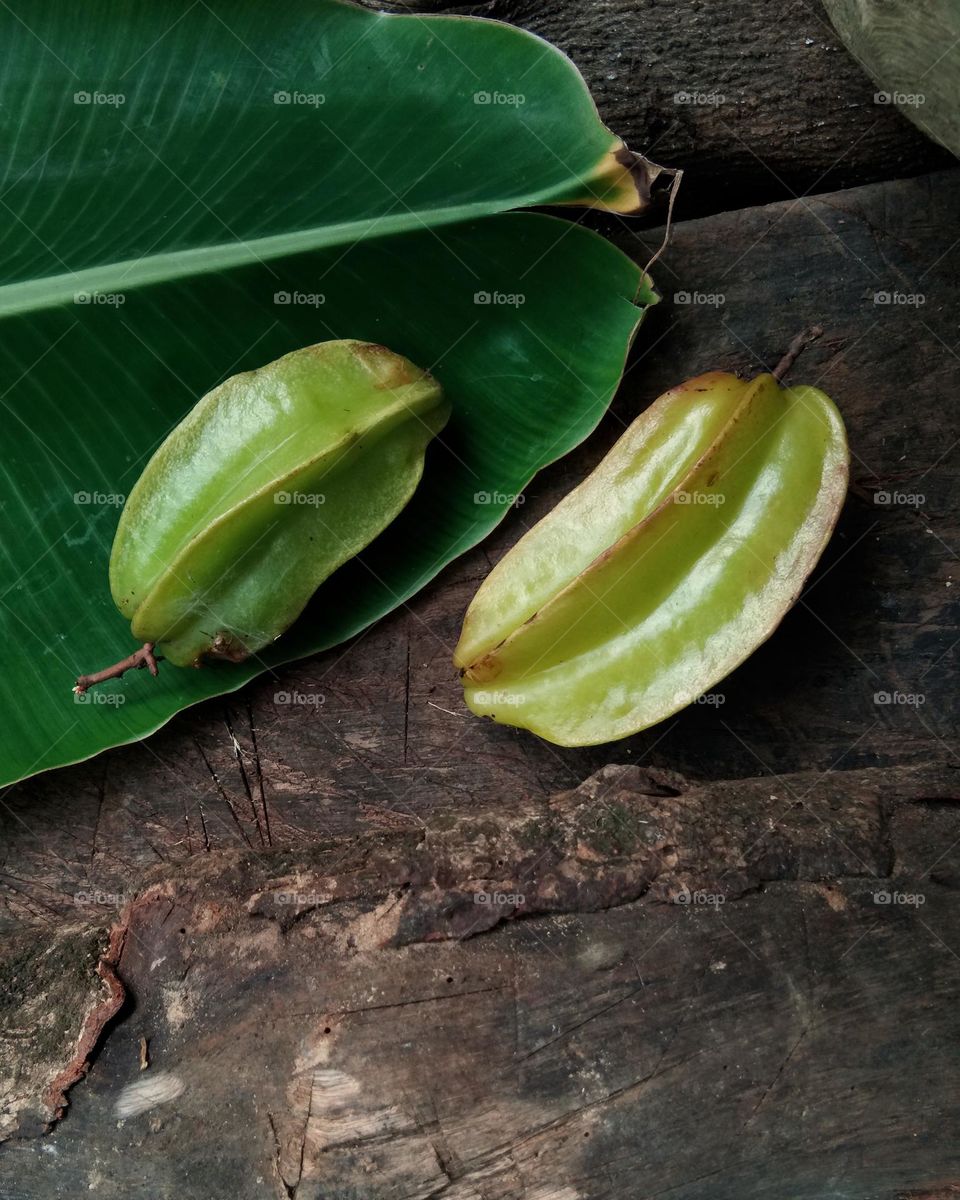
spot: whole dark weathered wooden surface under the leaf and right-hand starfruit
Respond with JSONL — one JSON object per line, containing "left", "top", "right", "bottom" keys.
{"left": 0, "top": 172, "right": 960, "bottom": 1200}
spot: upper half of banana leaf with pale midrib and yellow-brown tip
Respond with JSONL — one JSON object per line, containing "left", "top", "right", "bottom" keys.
{"left": 0, "top": 0, "right": 660, "bottom": 300}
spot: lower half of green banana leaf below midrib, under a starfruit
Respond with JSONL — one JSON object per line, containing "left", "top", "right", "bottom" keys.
{"left": 0, "top": 214, "right": 655, "bottom": 782}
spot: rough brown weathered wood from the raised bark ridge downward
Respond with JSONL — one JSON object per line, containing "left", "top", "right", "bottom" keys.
{"left": 0, "top": 767, "right": 960, "bottom": 1200}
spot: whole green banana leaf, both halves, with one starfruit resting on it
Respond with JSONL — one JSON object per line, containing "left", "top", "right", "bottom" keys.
{"left": 0, "top": 0, "right": 660, "bottom": 782}
